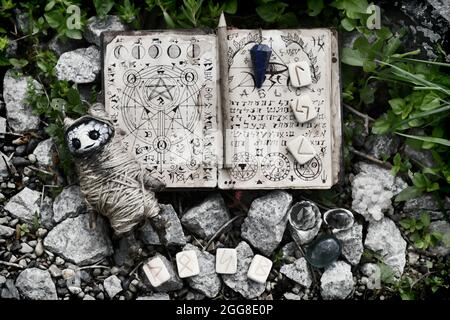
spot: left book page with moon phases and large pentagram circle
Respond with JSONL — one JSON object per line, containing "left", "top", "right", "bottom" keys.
{"left": 103, "top": 31, "right": 222, "bottom": 188}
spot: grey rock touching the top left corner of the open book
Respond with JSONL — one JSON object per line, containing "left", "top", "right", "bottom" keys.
{"left": 84, "top": 15, "right": 128, "bottom": 47}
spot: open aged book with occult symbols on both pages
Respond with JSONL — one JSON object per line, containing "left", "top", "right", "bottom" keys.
{"left": 103, "top": 28, "right": 341, "bottom": 189}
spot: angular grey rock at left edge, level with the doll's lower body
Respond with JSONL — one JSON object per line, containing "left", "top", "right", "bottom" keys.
{"left": 5, "top": 187, "right": 41, "bottom": 223}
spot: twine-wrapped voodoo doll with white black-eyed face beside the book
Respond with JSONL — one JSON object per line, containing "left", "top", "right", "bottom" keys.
{"left": 64, "top": 105, "right": 164, "bottom": 235}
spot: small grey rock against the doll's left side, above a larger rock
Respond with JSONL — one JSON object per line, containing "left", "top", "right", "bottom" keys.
{"left": 53, "top": 185, "right": 86, "bottom": 223}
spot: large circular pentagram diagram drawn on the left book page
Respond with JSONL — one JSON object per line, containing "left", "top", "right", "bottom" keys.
{"left": 119, "top": 65, "right": 203, "bottom": 148}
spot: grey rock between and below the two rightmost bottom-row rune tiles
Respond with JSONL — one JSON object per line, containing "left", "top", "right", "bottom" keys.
{"left": 222, "top": 241, "right": 265, "bottom": 299}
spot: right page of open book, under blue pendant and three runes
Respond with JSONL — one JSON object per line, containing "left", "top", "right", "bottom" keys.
{"left": 219, "top": 29, "right": 341, "bottom": 189}
